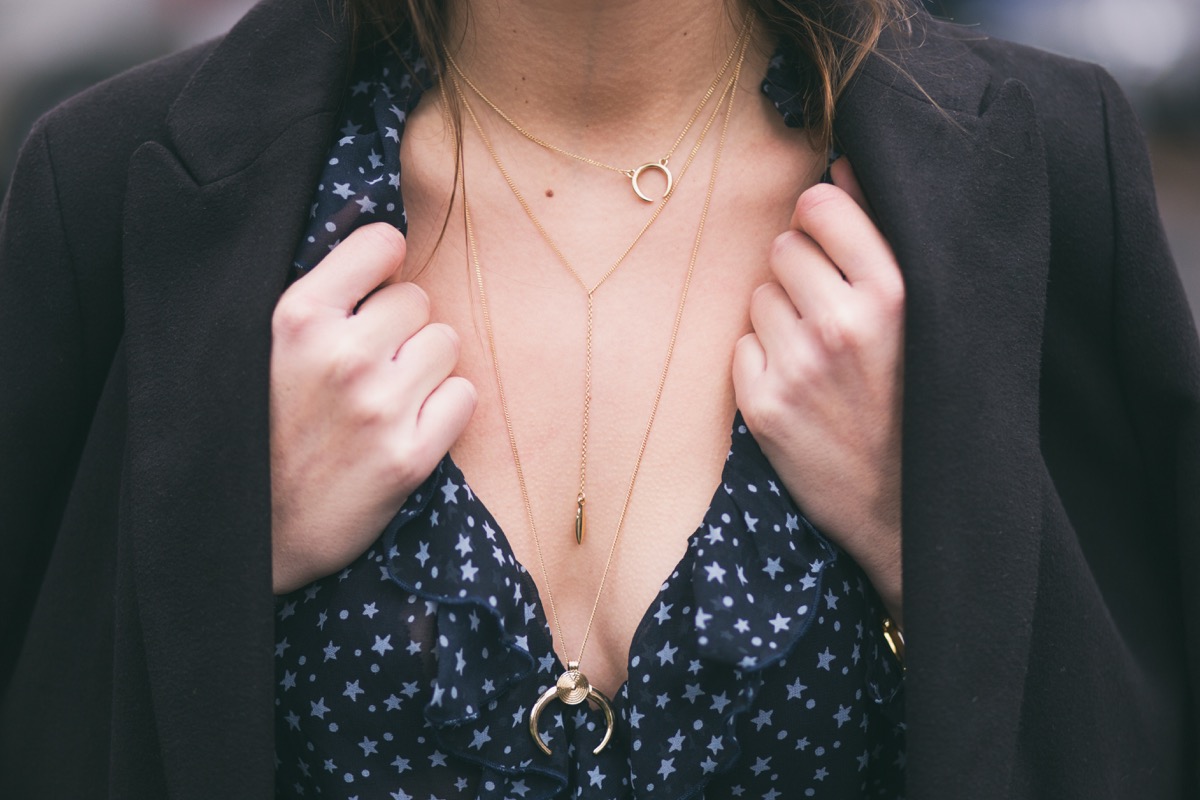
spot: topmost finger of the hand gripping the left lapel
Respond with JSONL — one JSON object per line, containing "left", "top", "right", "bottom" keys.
{"left": 288, "top": 222, "right": 406, "bottom": 315}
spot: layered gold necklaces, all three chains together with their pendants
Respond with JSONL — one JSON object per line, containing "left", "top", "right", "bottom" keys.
{"left": 451, "top": 16, "right": 751, "bottom": 756}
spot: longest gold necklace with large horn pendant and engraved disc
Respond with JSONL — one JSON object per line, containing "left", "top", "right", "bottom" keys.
{"left": 460, "top": 23, "right": 748, "bottom": 756}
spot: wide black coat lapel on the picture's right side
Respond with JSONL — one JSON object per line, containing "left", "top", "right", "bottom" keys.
{"left": 838, "top": 21, "right": 1050, "bottom": 800}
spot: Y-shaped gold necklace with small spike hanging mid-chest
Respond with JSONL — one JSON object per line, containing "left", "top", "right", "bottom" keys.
{"left": 443, "top": 48, "right": 749, "bottom": 545}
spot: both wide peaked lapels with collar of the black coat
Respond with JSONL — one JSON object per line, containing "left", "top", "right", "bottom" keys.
{"left": 122, "top": 0, "right": 1049, "bottom": 798}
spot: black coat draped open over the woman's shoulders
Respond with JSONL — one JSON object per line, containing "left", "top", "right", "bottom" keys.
{"left": 0, "top": 0, "right": 1200, "bottom": 800}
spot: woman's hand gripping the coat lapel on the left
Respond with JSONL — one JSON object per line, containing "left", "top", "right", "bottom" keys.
{"left": 270, "top": 223, "right": 476, "bottom": 594}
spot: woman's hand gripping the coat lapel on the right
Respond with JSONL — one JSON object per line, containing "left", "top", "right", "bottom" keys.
{"left": 733, "top": 158, "right": 905, "bottom": 624}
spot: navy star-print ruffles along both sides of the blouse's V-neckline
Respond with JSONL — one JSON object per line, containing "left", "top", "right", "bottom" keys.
{"left": 383, "top": 416, "right": 898, "bottom": 800}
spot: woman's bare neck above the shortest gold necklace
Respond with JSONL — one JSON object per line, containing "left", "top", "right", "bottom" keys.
{"left": 441, "top": 0, "right": 764, "bottom": 153}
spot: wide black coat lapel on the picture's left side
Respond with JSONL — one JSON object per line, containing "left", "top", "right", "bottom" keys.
{"left": 122, "top": 0, "right": 349, "bottom": 799}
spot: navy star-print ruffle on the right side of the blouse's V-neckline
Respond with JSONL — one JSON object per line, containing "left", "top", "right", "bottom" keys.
{"left": 626, "top": 413, "right": 840, "bottom": 798}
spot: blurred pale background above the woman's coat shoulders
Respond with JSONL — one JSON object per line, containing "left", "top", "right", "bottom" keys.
{"left": 0, "top": 0, "right": 1200, "bottom": 326}
